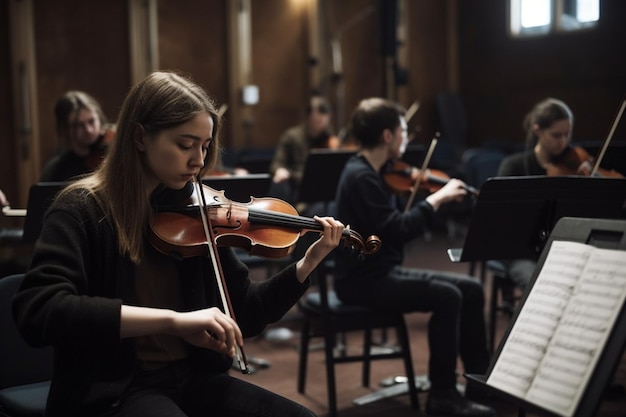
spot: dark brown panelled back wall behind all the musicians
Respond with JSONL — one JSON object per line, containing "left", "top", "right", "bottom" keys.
{"left": 0, "top": 0, "right": 626, "bottom": 214}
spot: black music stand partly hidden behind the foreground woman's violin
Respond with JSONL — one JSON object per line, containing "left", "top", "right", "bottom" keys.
{"left": 202, "top": 174, "right": 272, "bottom": 203}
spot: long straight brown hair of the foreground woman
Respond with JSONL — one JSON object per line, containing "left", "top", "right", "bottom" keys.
{"left": 61, "top": 71, "right": 221, "bottom": 263}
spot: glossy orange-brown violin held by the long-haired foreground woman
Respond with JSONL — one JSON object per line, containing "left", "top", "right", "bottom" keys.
{"left": 149, "top": 185, "right": 381, "bottom": 258}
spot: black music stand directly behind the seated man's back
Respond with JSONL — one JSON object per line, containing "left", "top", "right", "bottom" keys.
{"left": 296, "top": 149, "right": 356, "bottom": 203}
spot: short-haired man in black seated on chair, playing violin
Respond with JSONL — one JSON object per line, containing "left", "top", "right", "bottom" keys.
{"left": 335, "top": 98, "right": 495, "bottom": 417}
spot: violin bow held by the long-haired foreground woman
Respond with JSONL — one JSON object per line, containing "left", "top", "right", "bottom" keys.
{"left": 193, "top": 178, "right": 251, "bottom": 374}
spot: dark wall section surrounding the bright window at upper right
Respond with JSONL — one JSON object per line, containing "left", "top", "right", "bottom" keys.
{"left": 460, "top": 0, "right": 626, "bottom": 148}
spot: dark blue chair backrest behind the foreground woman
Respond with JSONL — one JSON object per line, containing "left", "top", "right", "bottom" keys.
{"left": 0, "top": 274, "right": 53, "bottom": 388}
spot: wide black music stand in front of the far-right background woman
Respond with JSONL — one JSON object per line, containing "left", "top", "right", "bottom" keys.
{"left": 448, "top": 176, "right": 626, "bottom": 262}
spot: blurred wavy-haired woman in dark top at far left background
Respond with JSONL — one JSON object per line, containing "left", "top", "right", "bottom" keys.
{"left": 39, "top": 90, "right": 115, "bottom": 182}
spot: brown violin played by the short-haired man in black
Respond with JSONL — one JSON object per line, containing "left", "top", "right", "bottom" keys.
{"left": 382, "top": 160, "right": 478, "bottom": 196}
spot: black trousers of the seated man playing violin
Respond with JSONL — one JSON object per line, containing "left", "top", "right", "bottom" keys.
{"left": 335, "top": 267, "right": 489, "bottom": 390}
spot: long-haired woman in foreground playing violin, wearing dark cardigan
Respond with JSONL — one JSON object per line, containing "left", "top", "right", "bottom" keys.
{"left": 13, "top": 72, "right": 344, "bottom": 417}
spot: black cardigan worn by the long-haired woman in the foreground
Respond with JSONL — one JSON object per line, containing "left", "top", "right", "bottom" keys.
{"left": 13, "top": 186, "right": 308, "bottom": 416}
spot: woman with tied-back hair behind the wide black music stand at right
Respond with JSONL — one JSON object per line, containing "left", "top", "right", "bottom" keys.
{"left": 498, "top": 98, "right": 574, "bottom": 291}
